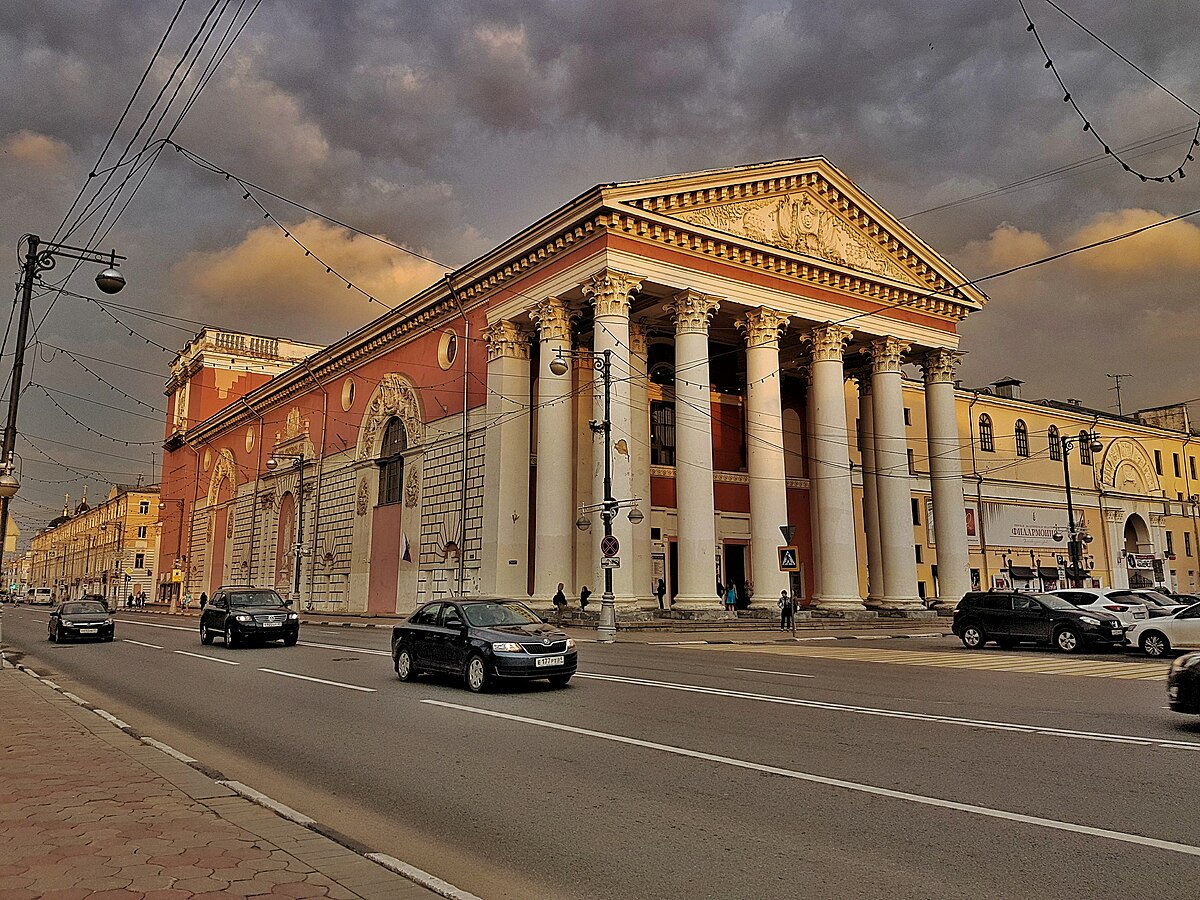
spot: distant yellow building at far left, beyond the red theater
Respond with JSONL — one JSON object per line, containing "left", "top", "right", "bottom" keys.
{"left": 29, "top": 485, "right": 160, "bottom": 602}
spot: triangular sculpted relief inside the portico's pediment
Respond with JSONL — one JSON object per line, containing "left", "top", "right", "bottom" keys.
{"left": 676, "top": 192, "right": 913, "bottom": 283}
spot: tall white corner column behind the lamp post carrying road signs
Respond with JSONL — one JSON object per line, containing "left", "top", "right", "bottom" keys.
{"left": 582, "top": 269, "right": 649, "bottom": 607}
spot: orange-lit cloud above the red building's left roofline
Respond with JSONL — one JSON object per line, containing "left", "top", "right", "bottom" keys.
{"left": 173, "top": 218, "right": 444, "bottom": 340}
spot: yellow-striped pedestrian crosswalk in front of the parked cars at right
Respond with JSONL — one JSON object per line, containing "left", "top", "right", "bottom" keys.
{"left": 685, "top": 644, "right": 1169, "bottom": 680}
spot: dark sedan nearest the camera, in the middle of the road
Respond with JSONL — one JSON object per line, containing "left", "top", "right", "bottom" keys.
{"left": 391, "top": 598, "right": 577, "bottom": 694}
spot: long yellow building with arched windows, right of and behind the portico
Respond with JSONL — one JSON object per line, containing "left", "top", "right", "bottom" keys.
{"left": 847, "top": 378, "right": 1200, "bottom": 602}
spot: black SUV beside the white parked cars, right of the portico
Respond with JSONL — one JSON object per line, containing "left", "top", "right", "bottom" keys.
{"left": 953, "top": 590, "right": 1126, "bottom": 653}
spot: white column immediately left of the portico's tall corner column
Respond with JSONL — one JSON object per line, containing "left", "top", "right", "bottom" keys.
{"left": 529, "top": 298, "right": 580, "bottom": 607}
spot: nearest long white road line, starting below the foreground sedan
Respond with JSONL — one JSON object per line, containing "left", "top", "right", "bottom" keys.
{"left": 421, "top": 700, "right": 1200, "bottom": 857}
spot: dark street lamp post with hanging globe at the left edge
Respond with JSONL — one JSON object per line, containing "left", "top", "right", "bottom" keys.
{"left": 0, "top": 234, "right": 125, "bottom": 609}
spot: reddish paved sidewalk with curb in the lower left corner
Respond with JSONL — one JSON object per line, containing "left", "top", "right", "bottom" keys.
{"left": 0, "top": 665, "right": 478, "bottom": 900}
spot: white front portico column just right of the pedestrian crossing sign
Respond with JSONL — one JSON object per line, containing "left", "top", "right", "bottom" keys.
{"left": 808, "top": 323, "right": 863, "bottom": 610}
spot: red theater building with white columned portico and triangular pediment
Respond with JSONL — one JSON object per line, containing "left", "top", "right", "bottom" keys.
{"left": 154, "top": 157, "right": 1194, "bottom": 617}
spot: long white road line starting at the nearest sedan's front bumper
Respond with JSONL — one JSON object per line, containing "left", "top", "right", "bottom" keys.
{"left": 575, "top": 672, "right": 1200, "bottom": 750}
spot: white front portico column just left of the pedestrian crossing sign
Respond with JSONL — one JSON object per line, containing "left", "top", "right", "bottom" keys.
{"left": 737, "top": 307, "right": 790, "bottom": 606}
